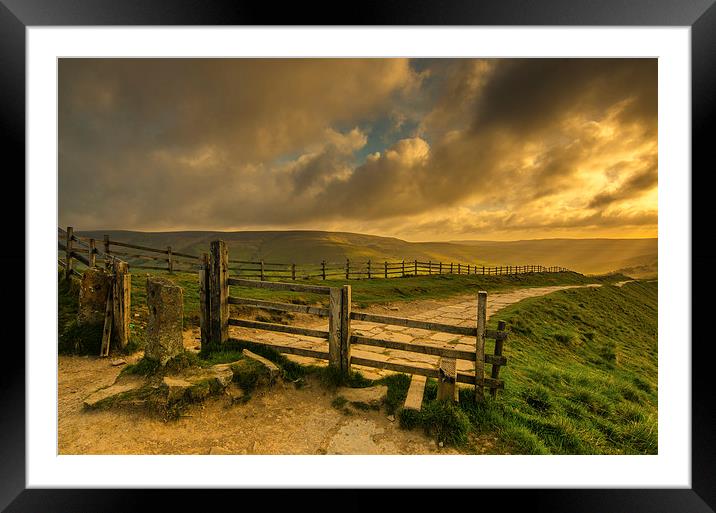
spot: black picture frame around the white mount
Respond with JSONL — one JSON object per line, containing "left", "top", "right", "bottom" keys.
{"left": 0, "top": 0, "right": 716, "bottom": 512}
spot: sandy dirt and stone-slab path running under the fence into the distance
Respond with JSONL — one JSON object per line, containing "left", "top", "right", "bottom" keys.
{"left": 58, "top": 285, "right": 599, "bottom": 454}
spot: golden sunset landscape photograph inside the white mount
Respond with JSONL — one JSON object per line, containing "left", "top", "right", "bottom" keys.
{"left": 57, "top": 57, "right": 663, "bottom": 454}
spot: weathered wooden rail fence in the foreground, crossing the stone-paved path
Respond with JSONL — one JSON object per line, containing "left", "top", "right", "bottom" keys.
{"left": 199, "top": 241, "right": 507, "bottom": 400}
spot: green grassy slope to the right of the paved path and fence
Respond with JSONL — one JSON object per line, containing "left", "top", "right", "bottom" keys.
{"left": 465, "top": 282, "right": 658, "bottom": 454}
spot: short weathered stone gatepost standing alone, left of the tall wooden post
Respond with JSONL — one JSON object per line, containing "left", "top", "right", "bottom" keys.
{"left": 144, "top": 276, "right": 184, "bottom": 365}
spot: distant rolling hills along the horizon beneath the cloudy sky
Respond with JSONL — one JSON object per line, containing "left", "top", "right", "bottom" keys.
{"left": 77, "top": 230, "right": 658, "bottom": 277}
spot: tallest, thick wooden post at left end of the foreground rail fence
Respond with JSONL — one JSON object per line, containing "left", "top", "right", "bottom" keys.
{"left": 209, "top": 240, "right": 229, "bottom": 349}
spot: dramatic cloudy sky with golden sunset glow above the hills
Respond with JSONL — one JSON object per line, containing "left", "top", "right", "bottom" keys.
{"left": 58, "top": 58, "right": 658, "bottom": 241}
